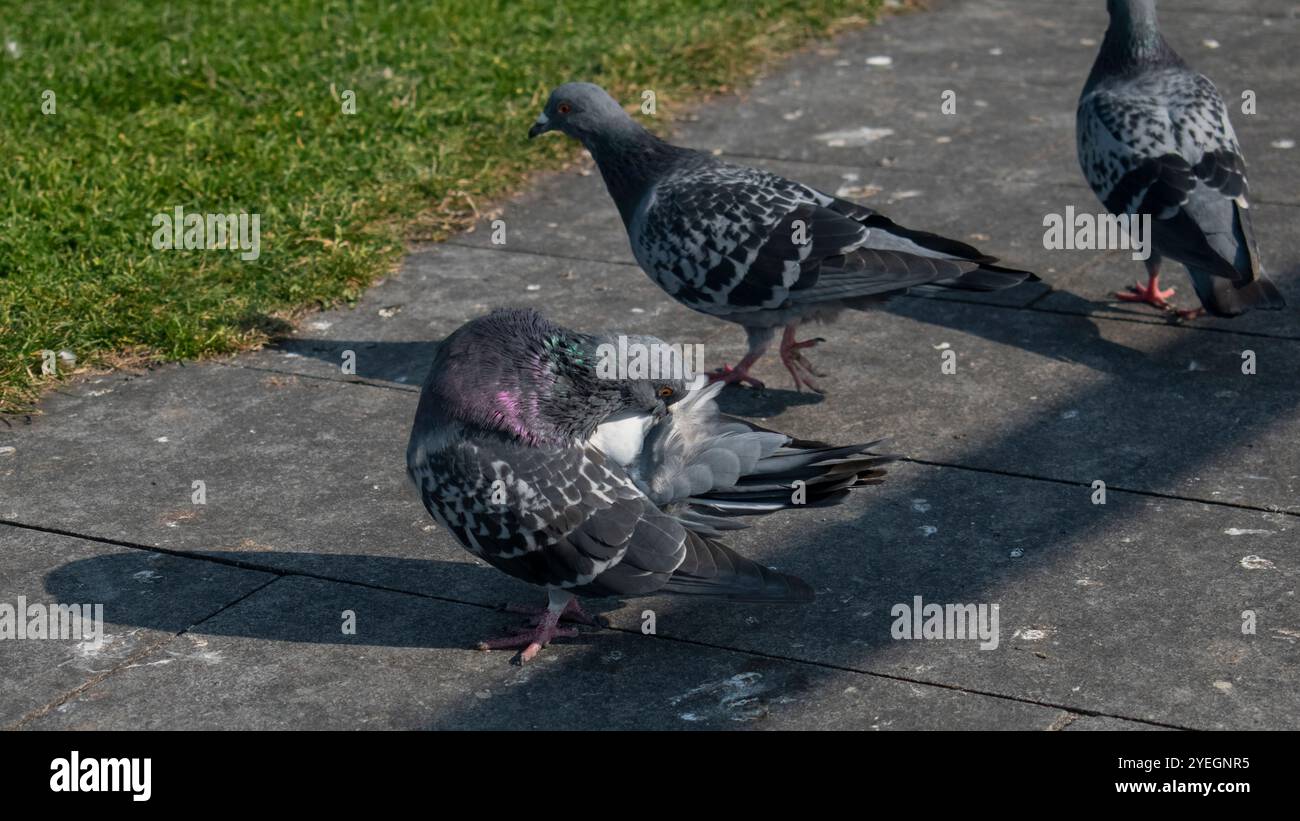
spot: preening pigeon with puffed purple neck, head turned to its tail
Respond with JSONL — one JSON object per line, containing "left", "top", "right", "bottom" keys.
{"left": 407, "top": 309, "right": 891, "bottom": 663}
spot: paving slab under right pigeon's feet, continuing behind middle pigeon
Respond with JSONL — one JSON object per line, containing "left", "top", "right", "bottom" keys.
{"left": 452, "top": 160, "right": 1300, "bottom": 339}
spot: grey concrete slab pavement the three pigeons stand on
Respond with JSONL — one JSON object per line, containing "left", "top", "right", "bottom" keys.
{"left": 0, "top": 0, "right": 1300, "bottom": 730}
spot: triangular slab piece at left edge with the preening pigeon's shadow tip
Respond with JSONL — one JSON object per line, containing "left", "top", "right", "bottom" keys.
{"left": 0, "top": 525, "right": 274, "bottom": 727}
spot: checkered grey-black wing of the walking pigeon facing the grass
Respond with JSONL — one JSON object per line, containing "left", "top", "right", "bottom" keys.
{"left": 629, "top": 162, "right": 1032, "bottom": 316}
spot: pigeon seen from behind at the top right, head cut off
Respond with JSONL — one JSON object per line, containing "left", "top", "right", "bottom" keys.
{"left": 1076, "top": 0, "right": 1286, "bottom": 318}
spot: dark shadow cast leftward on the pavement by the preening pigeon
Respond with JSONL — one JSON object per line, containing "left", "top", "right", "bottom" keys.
{"left": 44, "top": 551, "right": 621, "bottom": 650}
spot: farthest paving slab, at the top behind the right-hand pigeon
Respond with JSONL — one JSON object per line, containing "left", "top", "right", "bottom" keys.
{"left": 677, "top": 0, "right": 1300, "bottom": 204}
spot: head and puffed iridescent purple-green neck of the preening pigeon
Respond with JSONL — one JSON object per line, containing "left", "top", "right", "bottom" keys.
{"left": 417, "top": 309, "right": 685, "bottom": 444}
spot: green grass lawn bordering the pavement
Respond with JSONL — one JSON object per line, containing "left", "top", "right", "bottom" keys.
{"left": 0, "top": 0, "right": 879, "bottom": 411}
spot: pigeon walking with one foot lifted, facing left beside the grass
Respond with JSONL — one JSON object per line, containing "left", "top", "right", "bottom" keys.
{"left": 528, "top": 83, "right": 1037, "bottom": 391}
